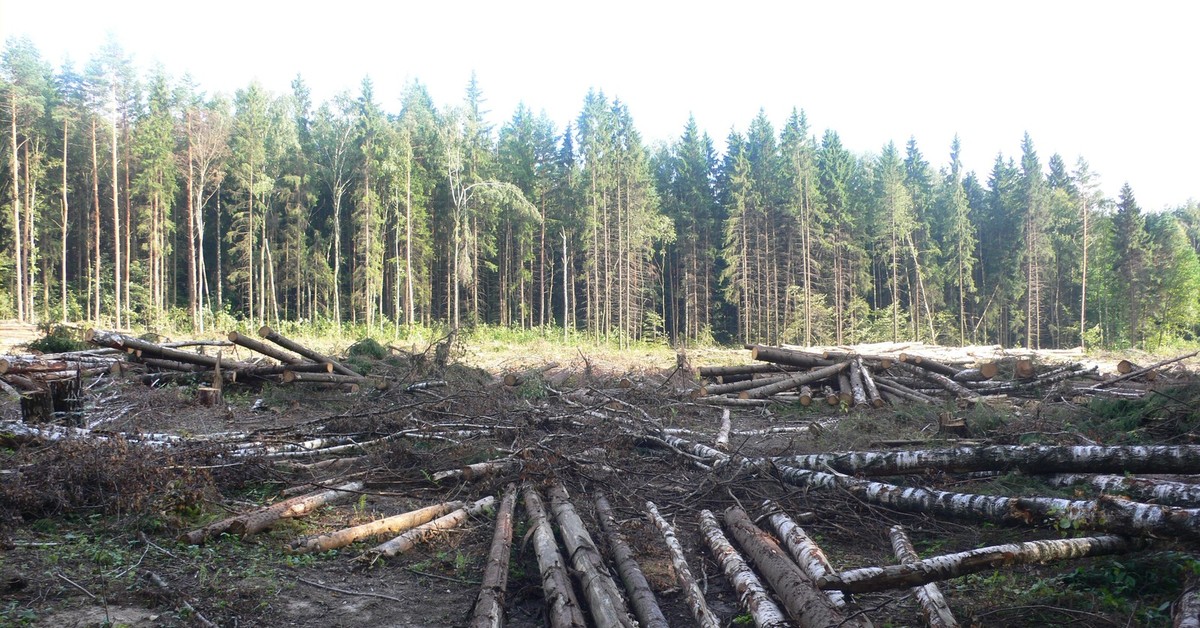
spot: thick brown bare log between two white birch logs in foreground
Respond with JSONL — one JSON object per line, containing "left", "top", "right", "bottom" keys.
{"left": 725, "top": 507, "right": 864, "bottom": 628}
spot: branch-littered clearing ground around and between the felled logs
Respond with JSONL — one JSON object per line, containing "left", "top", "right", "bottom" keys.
{"left": 0, "top": 343, "right": 1200, "bottom": 627}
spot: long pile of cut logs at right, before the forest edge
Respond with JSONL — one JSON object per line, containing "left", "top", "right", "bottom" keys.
{"left": 696, "top": 345, "right": 1200, "bottom": 409}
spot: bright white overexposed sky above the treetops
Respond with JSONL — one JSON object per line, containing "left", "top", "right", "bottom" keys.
{"left": 0, "top": 0, "right": 1200, "bottom": 210}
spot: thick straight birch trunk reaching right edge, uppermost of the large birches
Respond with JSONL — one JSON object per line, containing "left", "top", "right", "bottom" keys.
{"left": 772, "top": 445, "right": 1200, "bottom": 476}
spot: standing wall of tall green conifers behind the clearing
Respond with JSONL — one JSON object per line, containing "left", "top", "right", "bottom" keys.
{"left": 0, "top": 38, "right": 1200, "bottom": 349}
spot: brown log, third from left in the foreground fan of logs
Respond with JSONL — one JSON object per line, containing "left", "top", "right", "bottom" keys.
{"left": 546, "top": 483, "right": 637, "bottom": 628}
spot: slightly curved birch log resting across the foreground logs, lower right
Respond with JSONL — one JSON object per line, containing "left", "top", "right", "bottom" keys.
{"left": 820, "top": 536, "right": 1147, "bottom": 593}
